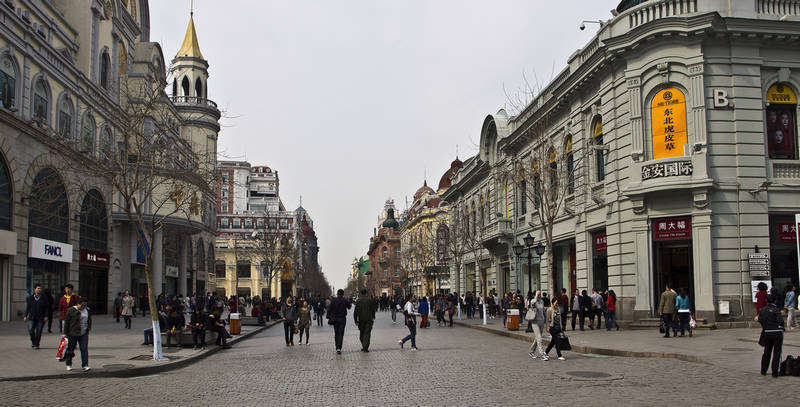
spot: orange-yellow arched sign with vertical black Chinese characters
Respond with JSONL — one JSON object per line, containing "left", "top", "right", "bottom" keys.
{"left": 650, "top": 88, "right": 686, "bottom": 160}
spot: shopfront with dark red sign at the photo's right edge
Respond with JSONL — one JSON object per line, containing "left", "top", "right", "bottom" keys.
{"left": 769, "top": 214, "right": 798, "bottom": 291}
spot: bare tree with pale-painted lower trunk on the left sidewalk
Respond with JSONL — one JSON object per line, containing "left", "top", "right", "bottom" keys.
{"left": 65, "top": 76, "right": 216, "bottom": 360}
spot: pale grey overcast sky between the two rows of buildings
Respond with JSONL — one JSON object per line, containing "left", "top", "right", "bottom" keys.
{"left": 150, "top": 0, "right": 618, "bottom": 288}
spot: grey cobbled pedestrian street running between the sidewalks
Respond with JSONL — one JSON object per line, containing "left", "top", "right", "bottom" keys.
{"left": 0, "top": 313, "right": 788, "bottom": 406}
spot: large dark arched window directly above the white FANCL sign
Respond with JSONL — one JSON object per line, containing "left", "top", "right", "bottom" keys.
{"left": 28, "top": 168, "right": 69, "bottom": 242}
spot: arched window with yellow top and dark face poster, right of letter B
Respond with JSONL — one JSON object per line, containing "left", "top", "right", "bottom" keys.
{"left": 764, "top": 83, "right": 798, "bottom": 160}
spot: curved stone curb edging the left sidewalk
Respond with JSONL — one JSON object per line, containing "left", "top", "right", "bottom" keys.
{"left": 0, "top": 320, "right": 282, "bottom": 382}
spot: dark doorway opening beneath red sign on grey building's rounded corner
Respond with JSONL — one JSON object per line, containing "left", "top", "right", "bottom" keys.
{"left": 653, "top": 241, "right": 694, "bottom": 312}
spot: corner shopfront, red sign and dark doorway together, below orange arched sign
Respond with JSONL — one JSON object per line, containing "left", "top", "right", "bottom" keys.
{"left": 653, "top": 216, "right": 695, "bottom": 311}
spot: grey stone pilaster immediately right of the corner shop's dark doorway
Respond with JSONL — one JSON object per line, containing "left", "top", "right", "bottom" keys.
{"left": 692, "top": 212, "right": 716, "bottom": 321}
